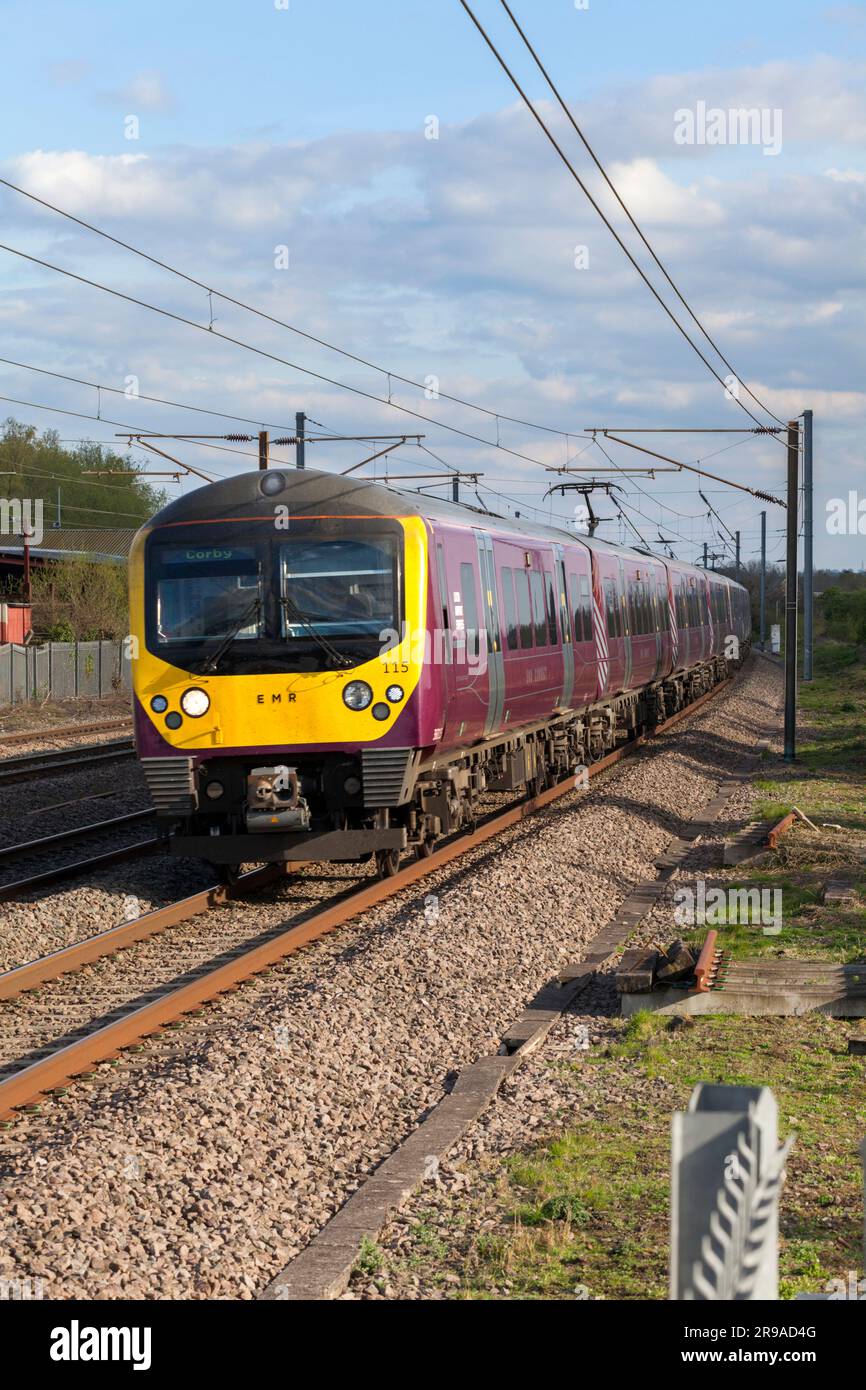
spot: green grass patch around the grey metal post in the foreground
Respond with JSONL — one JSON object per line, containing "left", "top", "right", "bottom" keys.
{"left": 455, "top": 1013, "right": 866, "bottom": 1300}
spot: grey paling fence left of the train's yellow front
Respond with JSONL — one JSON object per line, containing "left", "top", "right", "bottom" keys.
{"left": 0, "top": 641, "right": 132, "bottom": 709}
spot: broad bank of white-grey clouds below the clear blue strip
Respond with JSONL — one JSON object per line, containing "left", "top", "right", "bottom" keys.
{"left": 0, "top": 51, "right": 866, "bottom": 567}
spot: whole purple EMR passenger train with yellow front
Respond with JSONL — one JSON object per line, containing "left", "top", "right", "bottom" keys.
{"left": 129, "top": 467, "right": 752, "bottom": 881}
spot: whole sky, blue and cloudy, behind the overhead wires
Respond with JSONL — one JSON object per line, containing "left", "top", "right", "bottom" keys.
{"left": 0, "top": 0, "right": 866, "bottom": 569}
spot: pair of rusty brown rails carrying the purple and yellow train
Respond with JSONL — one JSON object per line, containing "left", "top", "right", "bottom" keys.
{"left": 0, "top": 680, "right": 731, "bottom": 1122}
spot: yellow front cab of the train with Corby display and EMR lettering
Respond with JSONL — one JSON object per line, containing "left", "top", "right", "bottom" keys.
{"left": 131, "top": 500, "right": 441, "bottom": 867}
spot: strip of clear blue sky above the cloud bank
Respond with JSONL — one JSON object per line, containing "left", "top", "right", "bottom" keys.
{"left": 6, "top": 0, "right": 866, "bottom": 156}
